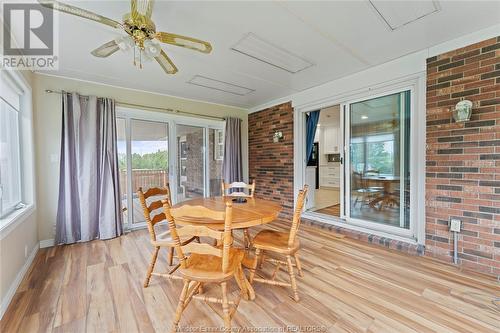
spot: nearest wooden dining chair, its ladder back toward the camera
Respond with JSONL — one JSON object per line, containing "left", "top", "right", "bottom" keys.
{"left": 163, "top": 201, "right": 247, "bottom": 331}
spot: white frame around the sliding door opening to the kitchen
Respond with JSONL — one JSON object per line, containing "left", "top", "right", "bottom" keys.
{"left": 292, "top": 72, "right": 426, "bottom": 244}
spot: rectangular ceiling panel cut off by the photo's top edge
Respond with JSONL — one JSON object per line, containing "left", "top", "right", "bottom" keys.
{"left": 369, "top": 0, "right": 441, "bottom": 30}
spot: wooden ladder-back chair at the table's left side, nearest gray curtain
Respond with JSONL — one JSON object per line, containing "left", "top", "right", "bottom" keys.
{"left": 137, "top": 185, "right": 196, "bottom": 288}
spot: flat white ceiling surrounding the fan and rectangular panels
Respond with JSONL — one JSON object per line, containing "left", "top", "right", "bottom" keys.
{"left": 29, "top": 1, "right": 500, "bottom": 108}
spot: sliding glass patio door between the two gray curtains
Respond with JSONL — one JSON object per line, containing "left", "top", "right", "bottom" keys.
{"left": 116, "top": 108, "right": 224, "bottom": 228}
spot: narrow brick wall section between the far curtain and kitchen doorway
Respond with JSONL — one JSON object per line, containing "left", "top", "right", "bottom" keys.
{"left": 248, "top": 103, "right": 293, "bottom": 217}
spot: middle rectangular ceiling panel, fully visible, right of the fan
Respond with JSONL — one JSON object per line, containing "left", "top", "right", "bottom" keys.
{"left": 231, "top": 33, "right": 314, "bottom": 73}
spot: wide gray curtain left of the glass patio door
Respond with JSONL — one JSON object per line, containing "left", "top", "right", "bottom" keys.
{"left": 56, "top": 92, "right": 123, "bottom": 244}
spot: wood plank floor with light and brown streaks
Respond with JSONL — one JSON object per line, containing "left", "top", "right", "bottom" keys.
{"left": 0, "top": 222, "right": 500, "bottom": 333}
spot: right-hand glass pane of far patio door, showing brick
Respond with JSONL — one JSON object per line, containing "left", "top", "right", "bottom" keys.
{"left": 176, "top": 125, "right": 206, "bottom": 202}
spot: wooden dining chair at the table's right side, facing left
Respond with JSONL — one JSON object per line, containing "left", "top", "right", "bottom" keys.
{"left": 250, "top": 185, "right": 309, "bottom": 302}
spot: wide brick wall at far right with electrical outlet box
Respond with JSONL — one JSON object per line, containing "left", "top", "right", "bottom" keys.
{"left": 425, "top": 37, "right": 500, "bottom": 275}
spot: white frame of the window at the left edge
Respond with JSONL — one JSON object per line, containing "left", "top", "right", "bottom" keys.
{"left": 0, "top": 69, "right": 36, "bottom": 239}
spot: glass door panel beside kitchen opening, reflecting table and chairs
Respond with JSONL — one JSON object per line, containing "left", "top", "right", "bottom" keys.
{"left": 348, "top": 91, "right": 410, "bottom": 229}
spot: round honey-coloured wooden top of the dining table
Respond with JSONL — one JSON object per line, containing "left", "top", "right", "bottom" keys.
{"left": 173, "top": 197, "right": 282, "bottom": 230}
